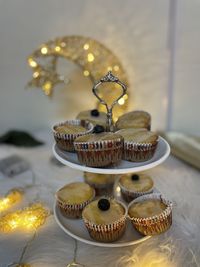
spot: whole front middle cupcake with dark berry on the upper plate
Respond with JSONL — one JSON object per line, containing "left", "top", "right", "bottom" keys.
{"left": 74, "top": 125, "right": 123, "bottom": 167}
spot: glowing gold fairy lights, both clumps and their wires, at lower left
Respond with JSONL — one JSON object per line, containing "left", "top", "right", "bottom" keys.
{"left": 0, "top": 173, "right": 84, "bottom": 267}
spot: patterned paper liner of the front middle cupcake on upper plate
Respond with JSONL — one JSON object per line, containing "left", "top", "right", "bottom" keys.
{"left": 74, "top": 138, "right": 123, "bottom": 167}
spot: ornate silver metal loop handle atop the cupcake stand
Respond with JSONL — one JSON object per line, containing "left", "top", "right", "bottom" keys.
{"left": 92, "top": 71, "right": 127, "bottom": 132}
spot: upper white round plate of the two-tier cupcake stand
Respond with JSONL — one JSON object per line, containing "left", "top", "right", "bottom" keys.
{"left": 53, "top": 137, "right": 170, "bottom": 174}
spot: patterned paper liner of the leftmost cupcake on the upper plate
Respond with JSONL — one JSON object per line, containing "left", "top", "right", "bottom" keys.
{"left": 53, "top": 120, "right": 94, "bottom": 152}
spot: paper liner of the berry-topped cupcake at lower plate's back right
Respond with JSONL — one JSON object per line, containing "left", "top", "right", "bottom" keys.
{"left": 118, "top": 181, "right": 153, "bottom": 202}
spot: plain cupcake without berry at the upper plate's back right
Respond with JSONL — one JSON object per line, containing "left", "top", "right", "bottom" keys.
{"left": 116, "top": 110, "right": 151, "bottom": 130}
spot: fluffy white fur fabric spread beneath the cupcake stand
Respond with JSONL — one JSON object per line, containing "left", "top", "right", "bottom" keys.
{"left": 0, "top": 133, "right": 200, "bottom": 267}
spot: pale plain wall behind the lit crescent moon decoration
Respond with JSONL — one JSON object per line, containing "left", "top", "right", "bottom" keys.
{"left": 0, "top": 0, "right": 200, "bottom": 134}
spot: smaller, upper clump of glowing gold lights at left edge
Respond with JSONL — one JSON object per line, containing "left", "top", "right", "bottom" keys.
{"left": 0, "top": 189, "right": 24, "bottom": 214}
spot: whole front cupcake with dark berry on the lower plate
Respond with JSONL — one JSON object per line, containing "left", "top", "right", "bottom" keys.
{"left": 82, "top": 198, "right": 127, "bottom": 242}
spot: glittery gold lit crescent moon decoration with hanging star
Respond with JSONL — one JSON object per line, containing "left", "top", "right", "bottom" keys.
{"left": 28, "top": 36, "right": 128, "bottom": 119}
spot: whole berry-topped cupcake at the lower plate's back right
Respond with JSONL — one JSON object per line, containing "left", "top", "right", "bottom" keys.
{"left": 119, "top": 173, "right": 154, "bottom": 202}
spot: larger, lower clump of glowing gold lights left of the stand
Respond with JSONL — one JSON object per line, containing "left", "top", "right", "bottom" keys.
{"left": 0, "top": 203, "right": 49, "bottom": 233}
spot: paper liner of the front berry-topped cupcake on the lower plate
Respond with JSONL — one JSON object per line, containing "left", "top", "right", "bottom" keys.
{"left": 83, "top": 201, "right": 127, "bottom": 242}
